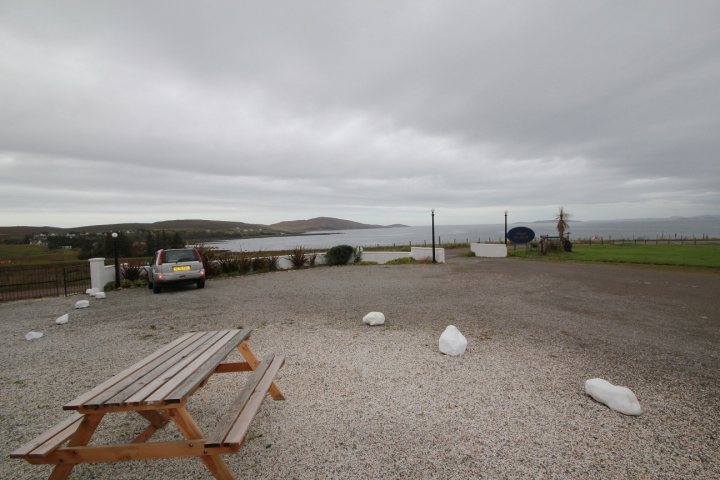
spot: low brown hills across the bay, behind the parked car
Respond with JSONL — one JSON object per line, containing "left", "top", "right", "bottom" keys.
{"left": 0, "top": 217, "right": 405, "bottom": 239}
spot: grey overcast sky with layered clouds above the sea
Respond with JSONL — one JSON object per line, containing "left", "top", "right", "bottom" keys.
{"left": 0, "top": 0, "right": 720, "bottom": 227}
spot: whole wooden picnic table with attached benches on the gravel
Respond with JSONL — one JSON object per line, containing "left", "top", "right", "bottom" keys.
{"left": 10, "top": 329, "right": 285, "bottom": 480}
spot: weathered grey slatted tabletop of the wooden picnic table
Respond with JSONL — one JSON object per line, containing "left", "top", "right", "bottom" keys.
{"left": 63, "top": 329, "right": 251, "bottom": 410}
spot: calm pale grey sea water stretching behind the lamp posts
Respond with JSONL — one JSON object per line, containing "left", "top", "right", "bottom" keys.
{"left": 210, "top": 216, "right": 720, "bottom": 252}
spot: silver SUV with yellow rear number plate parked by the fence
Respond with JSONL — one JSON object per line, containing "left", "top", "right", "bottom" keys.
{"left": 146, "top": 248, "right": 205, "bottom": 293}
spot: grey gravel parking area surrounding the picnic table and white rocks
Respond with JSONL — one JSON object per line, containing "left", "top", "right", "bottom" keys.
{"left": 0, "top": 256, "right": 720, "bottom": 480}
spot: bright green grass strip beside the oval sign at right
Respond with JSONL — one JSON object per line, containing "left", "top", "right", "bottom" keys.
{"left": 508, "top": 244, "right": 720, "bottom": 268}
